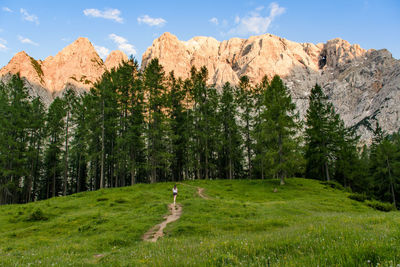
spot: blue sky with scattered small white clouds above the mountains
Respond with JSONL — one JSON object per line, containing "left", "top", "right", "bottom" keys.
{"left": 0, "top": 0, "right": 400, "bottom": 67}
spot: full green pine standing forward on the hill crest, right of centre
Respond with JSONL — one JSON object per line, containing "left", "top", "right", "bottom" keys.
{"left": 261, "top": 76, "right": 300, "bottom": 184}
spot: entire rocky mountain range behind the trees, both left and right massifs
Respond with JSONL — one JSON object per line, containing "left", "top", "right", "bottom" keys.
{"left": 0, "top": 33, "right": 400, "bottom": 143}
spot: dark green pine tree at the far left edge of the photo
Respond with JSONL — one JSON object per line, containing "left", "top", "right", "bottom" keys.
{"left": 0, "top": 75, "right": 31, "bottom": 203}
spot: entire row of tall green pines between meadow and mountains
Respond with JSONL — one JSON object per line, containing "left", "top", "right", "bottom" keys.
{"left": 0, "top": 59, "right": 400, "bottom": 209}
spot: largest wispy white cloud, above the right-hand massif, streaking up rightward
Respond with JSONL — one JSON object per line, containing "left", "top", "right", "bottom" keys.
{"left": 228, "top": 3, "right": 286, "bottom": 35}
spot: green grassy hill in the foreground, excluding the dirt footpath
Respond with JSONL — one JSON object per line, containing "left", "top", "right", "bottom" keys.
{"left": 0, "top": 178, "right": 400, "bottom": 266}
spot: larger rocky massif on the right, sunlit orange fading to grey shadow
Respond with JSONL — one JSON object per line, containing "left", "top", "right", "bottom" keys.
{"left": 142, "top": 33, "right": 400, "bottom": 143}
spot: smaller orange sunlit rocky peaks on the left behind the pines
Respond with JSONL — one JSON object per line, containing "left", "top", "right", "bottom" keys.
{"left": 0, "top": 37, "right": 127, "bottom": 105}
